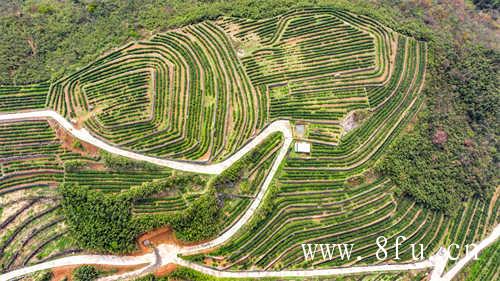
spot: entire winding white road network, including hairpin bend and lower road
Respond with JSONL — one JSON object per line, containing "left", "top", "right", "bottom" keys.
{"left": 0, "top": 110, "right": 500, "bottom": 281}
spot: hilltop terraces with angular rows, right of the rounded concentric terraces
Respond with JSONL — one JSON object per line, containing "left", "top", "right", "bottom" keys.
{"left": 220, "top": 9, "right": 402, "bottom": 144}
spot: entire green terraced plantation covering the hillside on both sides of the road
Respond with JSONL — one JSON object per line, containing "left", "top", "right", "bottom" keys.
{"left": 0, "top": 8, "right": 500, "bottom": 276}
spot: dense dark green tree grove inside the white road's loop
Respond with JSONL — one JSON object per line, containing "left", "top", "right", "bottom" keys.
{"left": 59, "top": 176, "right": 211, "bottom": 253}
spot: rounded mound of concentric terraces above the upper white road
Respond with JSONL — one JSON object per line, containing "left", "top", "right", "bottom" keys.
{"left": 42, "top": 22, "right": 266, "bottom": 161}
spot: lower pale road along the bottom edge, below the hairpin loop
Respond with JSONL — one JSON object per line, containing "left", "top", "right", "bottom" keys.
{"left": 0, "top": 225, "right": 500, "bottom": 281}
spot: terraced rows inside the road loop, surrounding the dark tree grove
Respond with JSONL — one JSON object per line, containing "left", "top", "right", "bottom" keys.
{"left": 0, "top": 120, "right": 281, "bottom": 272}
